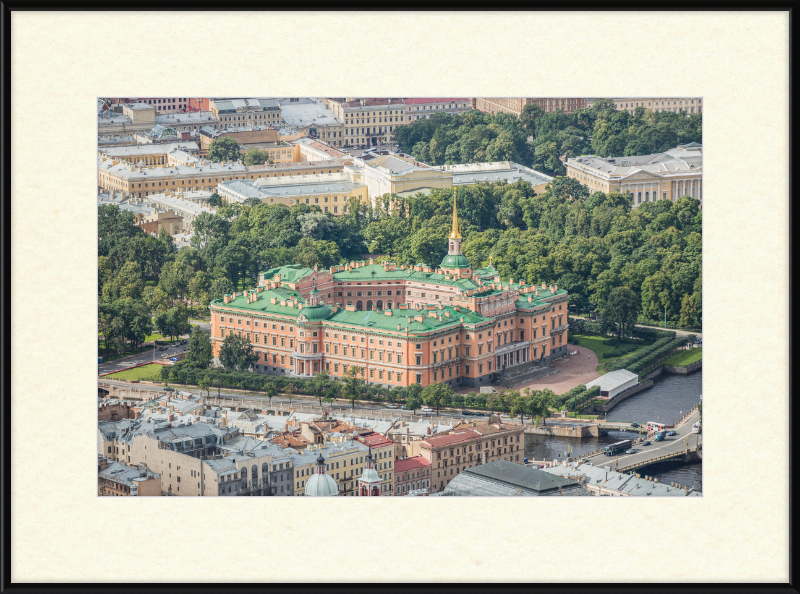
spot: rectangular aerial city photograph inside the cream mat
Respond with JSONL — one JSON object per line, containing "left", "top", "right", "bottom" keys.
{"left": 97, "top": 96, "right": 711, "bottom": 497}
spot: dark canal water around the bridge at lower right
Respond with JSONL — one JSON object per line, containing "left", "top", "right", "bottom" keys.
{"left": 525, "top": 369, "right": 703, "bottom": 491}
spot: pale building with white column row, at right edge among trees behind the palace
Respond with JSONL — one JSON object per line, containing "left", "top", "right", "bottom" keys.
{"left": 564, "top": 142, "right": 703, "bottom": 208}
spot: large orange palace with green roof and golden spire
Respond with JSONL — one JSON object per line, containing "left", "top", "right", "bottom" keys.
{"left": 209, "top": 194, "right": 568, "bottom": 388}
